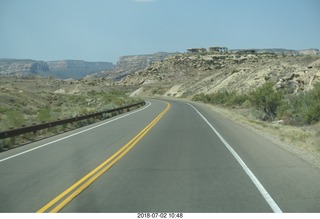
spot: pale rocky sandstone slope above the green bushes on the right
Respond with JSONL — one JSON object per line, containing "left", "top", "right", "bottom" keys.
{"left": 119, "top": 51, "right": 320, "bottom": 97}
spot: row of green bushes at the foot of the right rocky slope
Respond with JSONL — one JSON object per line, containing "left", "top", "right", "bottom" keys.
{"left": 192, "top": 82, "right": 320, "bottom": 125}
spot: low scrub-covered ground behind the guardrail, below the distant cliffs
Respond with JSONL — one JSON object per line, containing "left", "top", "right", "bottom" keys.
{"left": 0, "top": 75, "right": 136, "bottom": 130}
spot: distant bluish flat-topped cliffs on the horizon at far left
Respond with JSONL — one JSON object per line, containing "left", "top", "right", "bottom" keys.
{"left": 0, "top": 59, "right": 114, "bottom": 79}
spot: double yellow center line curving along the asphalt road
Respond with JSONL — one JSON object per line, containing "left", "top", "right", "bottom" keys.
{"left": 37, "top": 103, "right": 170, "bottom": 213}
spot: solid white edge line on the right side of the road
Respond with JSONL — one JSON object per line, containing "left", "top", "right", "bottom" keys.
{"left": 188, "top": 103, "right": 282, "bottom": 213}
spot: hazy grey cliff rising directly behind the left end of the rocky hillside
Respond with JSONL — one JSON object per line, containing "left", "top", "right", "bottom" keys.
{"left": 93, "top": 52, "right": 178, "bottom": 80}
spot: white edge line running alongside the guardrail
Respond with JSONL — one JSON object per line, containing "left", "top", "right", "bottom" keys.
{"left": 0, "top": 101, "right": 151, "bottom": 163}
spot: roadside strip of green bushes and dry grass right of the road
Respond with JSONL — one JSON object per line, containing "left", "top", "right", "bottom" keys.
{"left": 192, "top": 82, "right": 320, "bottom": 166}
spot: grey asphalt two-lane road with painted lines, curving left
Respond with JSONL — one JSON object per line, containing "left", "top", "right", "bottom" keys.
{"left": 0, "top": 99, "right": 320, "bottom": 213}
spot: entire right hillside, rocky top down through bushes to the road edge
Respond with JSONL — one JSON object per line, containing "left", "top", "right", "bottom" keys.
{"left": 118, "top": 49, "right": 320, "bottom": 161}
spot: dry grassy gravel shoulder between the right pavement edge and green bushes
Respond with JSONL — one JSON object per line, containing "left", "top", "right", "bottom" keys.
{"left": 200, "top": 103, "right": 320, "bottom": 168}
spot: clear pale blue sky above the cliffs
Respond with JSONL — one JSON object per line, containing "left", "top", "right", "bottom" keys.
{"left": 0, "top": 0, "right": 320, "bottom": 63}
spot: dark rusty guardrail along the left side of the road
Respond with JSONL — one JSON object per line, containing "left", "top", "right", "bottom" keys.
{"left": 0, "top": 101, "right": 145, "bottom": 151}
